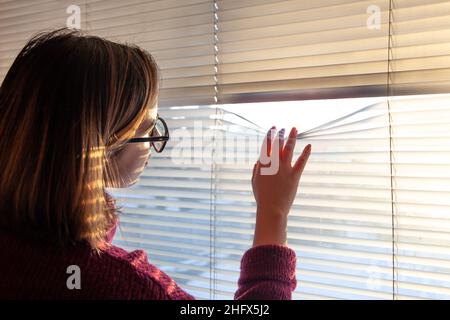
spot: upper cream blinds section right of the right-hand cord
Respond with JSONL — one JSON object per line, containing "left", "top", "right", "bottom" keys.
{"left": 390, "top": 0, "right": 450, "bottom": 95}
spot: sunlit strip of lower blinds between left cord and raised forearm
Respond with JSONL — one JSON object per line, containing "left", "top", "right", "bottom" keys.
{"left": 201, "top": 114, "right": 264, "bottom": 299}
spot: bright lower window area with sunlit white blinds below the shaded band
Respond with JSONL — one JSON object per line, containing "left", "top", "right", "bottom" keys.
{"left": 108, "top": 95, "right": 450, "bottom": 299}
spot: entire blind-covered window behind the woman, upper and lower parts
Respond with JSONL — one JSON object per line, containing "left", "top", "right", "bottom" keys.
{"left": 0, "top": 0, "right": 450, "bottom": 299}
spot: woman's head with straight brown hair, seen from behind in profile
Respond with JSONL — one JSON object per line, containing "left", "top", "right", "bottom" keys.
{"left": 0, "top": 29, "right": 160, "bottom": 248}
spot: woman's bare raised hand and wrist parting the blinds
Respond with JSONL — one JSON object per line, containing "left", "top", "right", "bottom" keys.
{"left": 252, "top": 127, "right": 311, "bottom": 246}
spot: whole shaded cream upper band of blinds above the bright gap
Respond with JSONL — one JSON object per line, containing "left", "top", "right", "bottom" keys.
{"left": 0, "top": 0, "right": 450, "bottom": 106}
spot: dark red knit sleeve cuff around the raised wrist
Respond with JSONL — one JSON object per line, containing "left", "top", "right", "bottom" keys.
{"left": 234, "top": 244, "right": 297, "bottom": 300}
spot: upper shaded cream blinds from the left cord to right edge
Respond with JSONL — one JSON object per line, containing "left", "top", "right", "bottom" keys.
{"left": 215, "top": 0, "right": 450, "bottom": 103}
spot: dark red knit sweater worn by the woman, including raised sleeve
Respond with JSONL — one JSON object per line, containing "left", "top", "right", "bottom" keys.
{"left": 0, "top": 216, "right": 297, "bottom": 300}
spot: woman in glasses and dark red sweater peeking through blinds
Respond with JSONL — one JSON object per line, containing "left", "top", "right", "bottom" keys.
{"left": 0, "top": 29, "right": 310, "bottom": 299}
